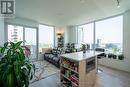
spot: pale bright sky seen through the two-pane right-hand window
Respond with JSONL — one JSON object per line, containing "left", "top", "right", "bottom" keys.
{"left": 78, "top": 16, "right": 123, "bottom": 43}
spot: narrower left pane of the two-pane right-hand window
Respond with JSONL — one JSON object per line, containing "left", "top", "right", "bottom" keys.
{"left": 78, "top": 23, "right": 94, "bottom": 49}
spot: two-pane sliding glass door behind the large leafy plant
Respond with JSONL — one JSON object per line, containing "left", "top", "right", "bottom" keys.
{"left": 7, "top": 25, "right": 37, "bottom": 59}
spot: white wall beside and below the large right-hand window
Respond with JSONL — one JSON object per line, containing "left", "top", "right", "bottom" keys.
{"left": 100, "top": 10, "right": 130, "bottom": 72}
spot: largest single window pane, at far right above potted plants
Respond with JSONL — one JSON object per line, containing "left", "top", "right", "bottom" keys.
{"left": 95, "top": 16, "right": 123, "bottom": 51}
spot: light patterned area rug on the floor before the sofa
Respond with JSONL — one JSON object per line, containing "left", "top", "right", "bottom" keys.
{"left": 30, "top": 60, "right": 60, "bottom": 83}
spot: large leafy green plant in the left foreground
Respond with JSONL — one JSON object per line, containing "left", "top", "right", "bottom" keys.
{"left": 0, "top": 41, "right": 35, "bottom": 87}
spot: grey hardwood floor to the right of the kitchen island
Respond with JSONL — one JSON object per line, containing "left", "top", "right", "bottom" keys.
{"left": 94, "top": 66, "right": 130, "bottom": 87}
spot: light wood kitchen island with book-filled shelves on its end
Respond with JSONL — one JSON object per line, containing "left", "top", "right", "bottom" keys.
{"left": 60, "top": 52, "right": 96, "bottom": 87}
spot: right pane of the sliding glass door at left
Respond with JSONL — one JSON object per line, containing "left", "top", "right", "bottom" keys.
{"left": 24, "top": 27, "right": 37, "bottom": 59}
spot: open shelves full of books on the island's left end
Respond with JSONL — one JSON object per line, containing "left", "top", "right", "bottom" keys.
{"left": 61, "top": 58, "right": 79, "bottom": 87}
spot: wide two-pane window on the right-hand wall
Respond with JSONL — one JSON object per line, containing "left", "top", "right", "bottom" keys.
{"left": 78, "top": 16, "right": 123, "bottom": 52}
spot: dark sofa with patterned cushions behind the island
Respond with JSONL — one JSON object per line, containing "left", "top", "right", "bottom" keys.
{"left": 44, "top": 47, "right": 64, "bottom": 67}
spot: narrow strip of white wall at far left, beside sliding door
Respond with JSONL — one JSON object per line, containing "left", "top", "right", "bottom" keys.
{"left": 0, "top": 18, "right": 5, "bottom": 46}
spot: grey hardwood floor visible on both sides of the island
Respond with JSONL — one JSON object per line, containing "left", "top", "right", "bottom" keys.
{"left": 29, "top": 66, "right": 130, "bottom": 87}
